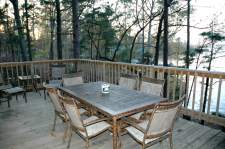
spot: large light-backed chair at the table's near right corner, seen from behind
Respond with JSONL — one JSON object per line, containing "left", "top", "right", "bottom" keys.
{"left": 126, "top": 98, "right": 183, "bottom": 149}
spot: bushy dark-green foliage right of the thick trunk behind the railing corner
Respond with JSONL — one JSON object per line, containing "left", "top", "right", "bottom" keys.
{"left": 81, "top": 5, "right": 116, "bottom": 57}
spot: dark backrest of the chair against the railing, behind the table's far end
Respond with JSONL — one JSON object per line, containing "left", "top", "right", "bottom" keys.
{"left": 51, "top": 65, "right": 66, "bottom": 80}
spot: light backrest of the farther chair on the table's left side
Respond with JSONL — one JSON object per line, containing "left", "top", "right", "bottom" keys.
{"left": 46, "top": 87, "right": 64, "bottom": 114}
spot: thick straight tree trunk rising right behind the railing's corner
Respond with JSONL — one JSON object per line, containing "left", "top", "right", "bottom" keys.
{"left": 72, "top": 0, "right": 80, "bottom": 58}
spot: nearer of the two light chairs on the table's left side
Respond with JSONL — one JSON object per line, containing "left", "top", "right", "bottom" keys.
{"left": 58, "top": 96, "right": 111, "bottom": 149}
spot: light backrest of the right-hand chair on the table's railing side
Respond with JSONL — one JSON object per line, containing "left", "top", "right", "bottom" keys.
{"left": 140, "top": 77, "right": 164, "bottom": 96}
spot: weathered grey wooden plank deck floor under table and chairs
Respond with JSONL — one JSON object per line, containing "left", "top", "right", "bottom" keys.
{"left": 0, "top": 92, "right": 225, "bottom": 149}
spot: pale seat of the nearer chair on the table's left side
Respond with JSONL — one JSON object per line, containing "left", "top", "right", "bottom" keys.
{"left": 80, "top": 116, "right": 110, "bottom": 137}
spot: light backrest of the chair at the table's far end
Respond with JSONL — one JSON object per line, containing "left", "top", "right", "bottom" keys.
{"left": 63, "top": 72, "right": 84, "bottom": 86}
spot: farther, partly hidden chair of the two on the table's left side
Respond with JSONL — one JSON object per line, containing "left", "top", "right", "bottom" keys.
{"left": 45, "top": 86, "right": 86, "bottom": 140}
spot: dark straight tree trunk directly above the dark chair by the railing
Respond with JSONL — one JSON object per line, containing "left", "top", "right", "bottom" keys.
{"left": 55, "top": 0, "right": 62, "bottom": 59}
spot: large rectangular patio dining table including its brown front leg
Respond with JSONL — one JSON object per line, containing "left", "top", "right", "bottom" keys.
{"left": 59, "top": 82, "right": 161, "bottom": 149}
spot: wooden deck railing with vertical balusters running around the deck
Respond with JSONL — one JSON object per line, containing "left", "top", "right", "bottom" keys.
{"left": 0, "top": 59, "right": 225, "bottom": 126}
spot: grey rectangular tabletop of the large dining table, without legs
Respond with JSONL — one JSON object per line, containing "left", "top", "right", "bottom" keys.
{"left": 59, "top": 82, "right": 162, "bottom": 116}
